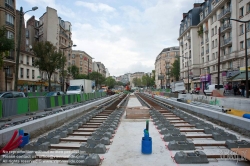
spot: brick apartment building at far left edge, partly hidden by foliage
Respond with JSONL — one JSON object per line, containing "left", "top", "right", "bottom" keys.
{"left": 0, "top": 0, "right": 16, "bottom": 91}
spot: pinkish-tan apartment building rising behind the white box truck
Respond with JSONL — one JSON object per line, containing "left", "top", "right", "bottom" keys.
{"left": 70, "top": 50, "right": 93, "bottom": 75}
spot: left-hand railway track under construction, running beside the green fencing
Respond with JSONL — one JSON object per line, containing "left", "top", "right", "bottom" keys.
{"left": 1, "top": 95, "right": 127, "bottom": 165}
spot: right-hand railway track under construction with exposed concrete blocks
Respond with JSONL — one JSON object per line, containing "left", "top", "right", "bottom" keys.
{"left": 136, "top": 94, "right": 250, "bottom": 165}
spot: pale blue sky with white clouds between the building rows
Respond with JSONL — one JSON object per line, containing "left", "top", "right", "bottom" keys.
{"left": 16, "top": 0, "right": 198, "bottom": 76}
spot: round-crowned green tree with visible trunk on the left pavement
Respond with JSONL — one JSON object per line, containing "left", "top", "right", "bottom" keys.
{"left": 33, "top": 41, "right": 63, "bottom": 91}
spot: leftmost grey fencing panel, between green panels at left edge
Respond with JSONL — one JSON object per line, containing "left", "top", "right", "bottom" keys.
{"left": 2, "top": 98, "right": 17, "bottom": 117}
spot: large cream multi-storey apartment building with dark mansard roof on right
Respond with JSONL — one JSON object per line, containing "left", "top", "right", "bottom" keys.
{"left": 178, "top": 0, "right": 250, "bottom": 89}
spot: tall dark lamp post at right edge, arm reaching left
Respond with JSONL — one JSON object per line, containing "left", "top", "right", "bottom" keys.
{"left": 229, "top": 19, "right": 250, "bottom": 98}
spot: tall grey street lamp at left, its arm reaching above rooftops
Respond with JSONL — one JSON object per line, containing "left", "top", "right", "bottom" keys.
{"left": 14, "top": 6, "right": 38, "bottom": 91}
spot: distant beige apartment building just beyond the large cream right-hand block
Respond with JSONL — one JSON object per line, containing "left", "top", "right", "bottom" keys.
{"left": 155, "top": 47, "right": 180, "bottom": 89}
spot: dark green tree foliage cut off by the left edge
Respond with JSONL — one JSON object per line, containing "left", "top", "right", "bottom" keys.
{"left": 0, "top": 26, "right": 15, "bottom": 68}
